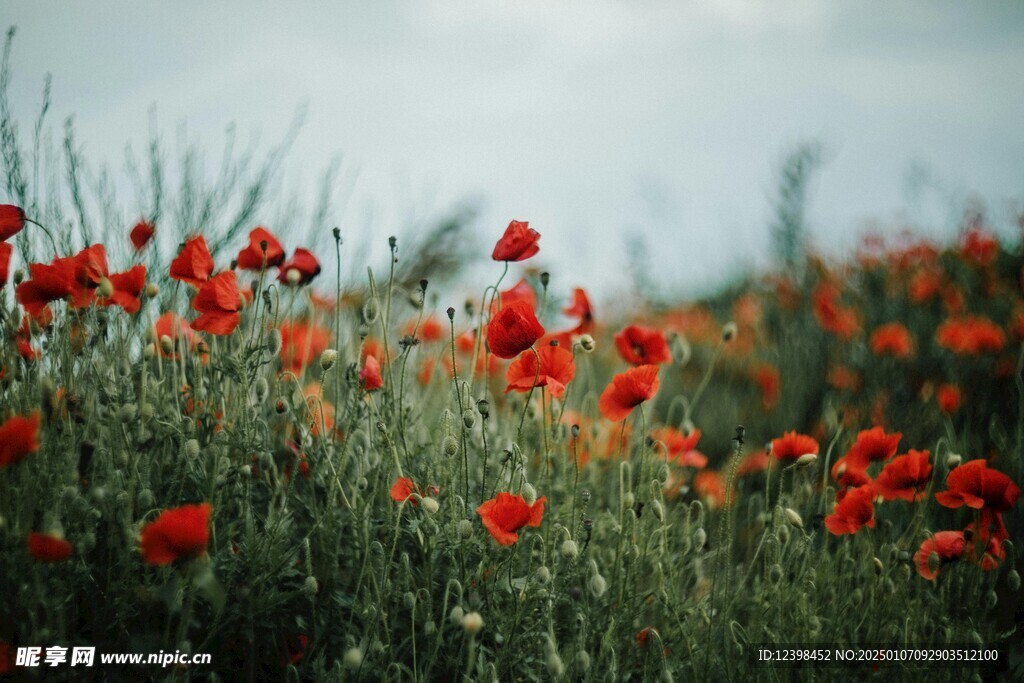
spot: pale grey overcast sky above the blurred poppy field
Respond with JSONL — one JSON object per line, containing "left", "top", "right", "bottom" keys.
{"left": 0, "top": 0, "right": 1024, "bottom": 296}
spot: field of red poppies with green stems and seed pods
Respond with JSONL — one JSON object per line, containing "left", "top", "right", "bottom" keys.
{"left": 0, "top": 41, "right": 1024, "bottom": 681}
